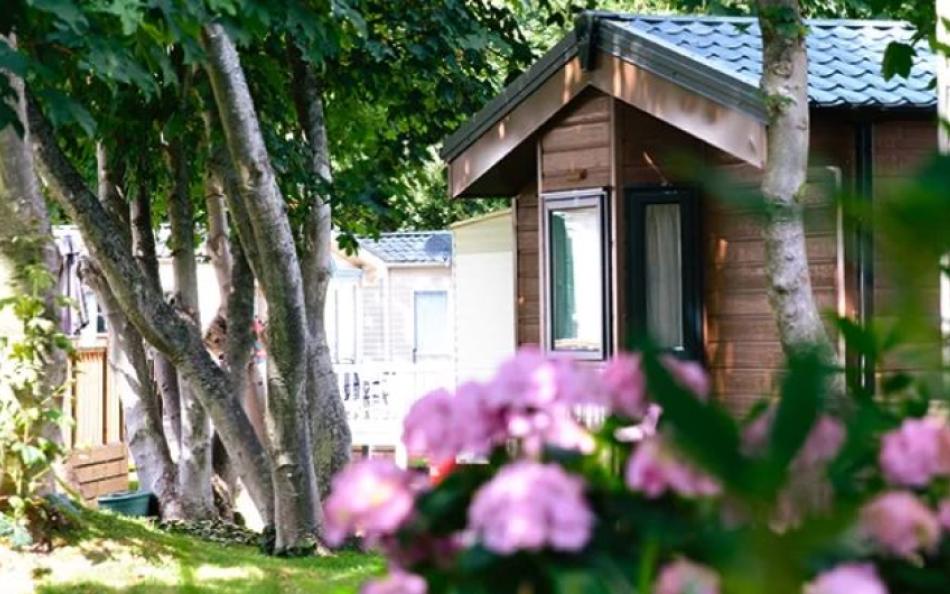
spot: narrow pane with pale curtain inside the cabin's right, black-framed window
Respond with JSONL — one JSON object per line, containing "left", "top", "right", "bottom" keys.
{"left": 644, "top": 204, "right": 683, "bottom": 349}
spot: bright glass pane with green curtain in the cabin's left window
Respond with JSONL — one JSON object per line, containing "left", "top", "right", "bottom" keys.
{"left": 550, "top": 206, "right": 604, "bottom": 352}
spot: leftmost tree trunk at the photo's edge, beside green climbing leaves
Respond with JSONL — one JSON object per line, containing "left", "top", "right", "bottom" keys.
{"left": 0, "top": 44, "right": 67, "bottom": 491}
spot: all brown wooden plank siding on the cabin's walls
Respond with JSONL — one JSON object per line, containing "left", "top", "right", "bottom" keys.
{"left": 514, "top": 90, "right": 939, "bottom": 412}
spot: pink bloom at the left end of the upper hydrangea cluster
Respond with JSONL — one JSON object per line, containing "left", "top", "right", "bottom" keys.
{"left": 402, "top": 389, "right": 460, "bottom": 462}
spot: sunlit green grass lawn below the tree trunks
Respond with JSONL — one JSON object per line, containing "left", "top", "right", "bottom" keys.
{"left": 0, "top": 512, "right": 383, "bottom": 594}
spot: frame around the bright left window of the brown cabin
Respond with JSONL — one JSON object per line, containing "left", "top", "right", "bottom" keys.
{"left": 539, "top": 188, "right": 612, "bottom": 361}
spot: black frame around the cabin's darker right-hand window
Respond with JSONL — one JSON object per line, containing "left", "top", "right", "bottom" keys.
{"left": 625, "top": 186, "right": 705, "bottom": 362}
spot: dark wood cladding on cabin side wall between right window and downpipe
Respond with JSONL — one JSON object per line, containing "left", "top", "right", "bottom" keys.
{"left": 620, "top": 105, "right": 851, "bottom": 410}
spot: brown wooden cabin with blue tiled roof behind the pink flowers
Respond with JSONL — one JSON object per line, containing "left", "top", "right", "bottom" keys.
{"left": 442, "top": 12, "right": 940, "bottom": 409}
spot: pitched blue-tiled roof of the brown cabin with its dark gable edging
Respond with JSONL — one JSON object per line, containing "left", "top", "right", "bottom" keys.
{"left": 441, "top": 11, "right": 937, "bottom": 161}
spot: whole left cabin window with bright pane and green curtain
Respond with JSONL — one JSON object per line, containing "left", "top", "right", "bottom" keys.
{"left": 544, "top": 191, "right": 607, "bottom": 359}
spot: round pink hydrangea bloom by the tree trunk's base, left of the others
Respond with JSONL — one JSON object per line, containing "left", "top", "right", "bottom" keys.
{"left": 323, "top": 458, "right": 414, "bottom": 546}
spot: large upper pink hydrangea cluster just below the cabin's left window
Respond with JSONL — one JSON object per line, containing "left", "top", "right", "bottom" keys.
{"left": 403, "top": 348, "right": 595, "bottom": 461}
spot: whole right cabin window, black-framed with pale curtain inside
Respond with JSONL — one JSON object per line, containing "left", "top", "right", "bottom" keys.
{"left": 627, "top": 189, "right": 702, "bottom": 358}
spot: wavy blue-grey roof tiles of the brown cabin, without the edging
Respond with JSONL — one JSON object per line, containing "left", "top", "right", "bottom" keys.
{"left": 604, "top": 14, "right": 937, "bottom": 107}
